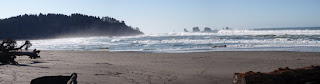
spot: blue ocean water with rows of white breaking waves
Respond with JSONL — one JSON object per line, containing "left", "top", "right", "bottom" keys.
{"left": 18, "top": 27, "right": 320, "bottom": 53}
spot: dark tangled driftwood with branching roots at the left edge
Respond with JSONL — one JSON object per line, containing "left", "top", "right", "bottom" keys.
{"left": 0, "top": 39, "right": 40, "bottom": 64}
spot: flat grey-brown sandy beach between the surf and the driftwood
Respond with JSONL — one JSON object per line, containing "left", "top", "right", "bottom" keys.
{"left": 0, "top": 51, "right": 320, "bottom": 84}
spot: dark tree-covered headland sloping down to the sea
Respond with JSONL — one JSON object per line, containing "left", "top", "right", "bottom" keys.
{"left": 0, "top": 13, "right": 143, "bottom": 39}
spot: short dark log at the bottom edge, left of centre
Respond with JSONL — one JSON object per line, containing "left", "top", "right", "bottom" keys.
{"left": 30, "top": 73, "right": 77, "bottom": 84}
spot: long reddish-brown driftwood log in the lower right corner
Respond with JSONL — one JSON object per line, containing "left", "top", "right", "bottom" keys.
{"left": 232, "top": 66, "right": 320, "bottom": 84}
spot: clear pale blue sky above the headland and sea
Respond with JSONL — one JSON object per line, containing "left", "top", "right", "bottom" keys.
{"left": 0, "top": 0, "right": 320, "bottom": 33}
